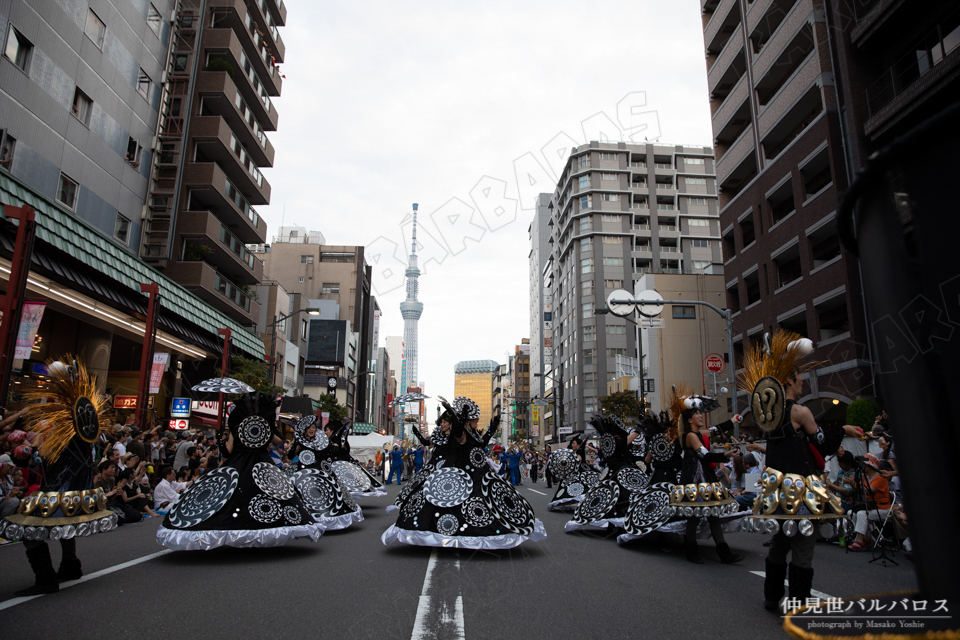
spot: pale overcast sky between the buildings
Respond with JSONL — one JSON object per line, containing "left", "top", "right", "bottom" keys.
{"left": 258, "top": 0, "right": 712, "bottom": 415}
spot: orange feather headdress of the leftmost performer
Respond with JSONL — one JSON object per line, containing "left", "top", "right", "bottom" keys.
{"left": 23, "top": 355, "right": 113, "bottom": 463}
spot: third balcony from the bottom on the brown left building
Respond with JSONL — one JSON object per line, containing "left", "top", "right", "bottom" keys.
{"left": 183, "top": 162, "right": 267, "bottom": 244}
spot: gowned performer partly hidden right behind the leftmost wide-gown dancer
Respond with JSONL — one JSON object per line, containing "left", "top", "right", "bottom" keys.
{"left": 290, "top": 415, "right": 363, "bottom": 531}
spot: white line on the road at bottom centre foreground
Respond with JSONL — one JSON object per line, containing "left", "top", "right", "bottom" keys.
{"left": 410, "top": 549, "right": 466, "bottom": 640}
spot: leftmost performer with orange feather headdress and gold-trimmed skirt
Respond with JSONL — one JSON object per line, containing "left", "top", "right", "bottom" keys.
{"left": 0, "top": 356, "right": 117, "bottom": 596}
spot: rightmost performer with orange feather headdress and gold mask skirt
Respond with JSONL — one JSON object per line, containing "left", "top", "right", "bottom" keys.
{"left": 738, "top": 331, "right": 863, "bottom": 611}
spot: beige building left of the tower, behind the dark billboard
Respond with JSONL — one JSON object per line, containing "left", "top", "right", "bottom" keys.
{"left": 257, "top": 227, "right": 378, "bottom": 422}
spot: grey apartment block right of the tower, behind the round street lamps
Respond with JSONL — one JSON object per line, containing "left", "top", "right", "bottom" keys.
{"left": 540, "top": 142, "right": 723, "bottom": 437}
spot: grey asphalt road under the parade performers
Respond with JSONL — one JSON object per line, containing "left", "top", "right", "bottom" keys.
{"left": 0, "top": 482, "right": 916, "bottom": 640}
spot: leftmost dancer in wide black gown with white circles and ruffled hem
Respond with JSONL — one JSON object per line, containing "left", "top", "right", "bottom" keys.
{"left": 157, "top": 393, "right": 324, "bottom": 551}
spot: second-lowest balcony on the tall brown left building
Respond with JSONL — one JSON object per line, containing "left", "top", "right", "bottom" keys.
{"left": 177, "top": 211, "right": 263, "bottom": 284}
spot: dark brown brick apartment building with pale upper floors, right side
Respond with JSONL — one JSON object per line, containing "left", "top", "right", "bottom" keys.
{"left": 701, "top": 0, "right": 873, "bottom": 419}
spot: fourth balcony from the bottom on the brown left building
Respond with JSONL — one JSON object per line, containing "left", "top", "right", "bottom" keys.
{"left": 190, "top": 116, "right": 270, "bottom": 204}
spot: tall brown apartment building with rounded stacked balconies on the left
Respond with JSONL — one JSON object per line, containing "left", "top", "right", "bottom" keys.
{"left": 140, "top": 0, "right": 289, "bottom": 325}
